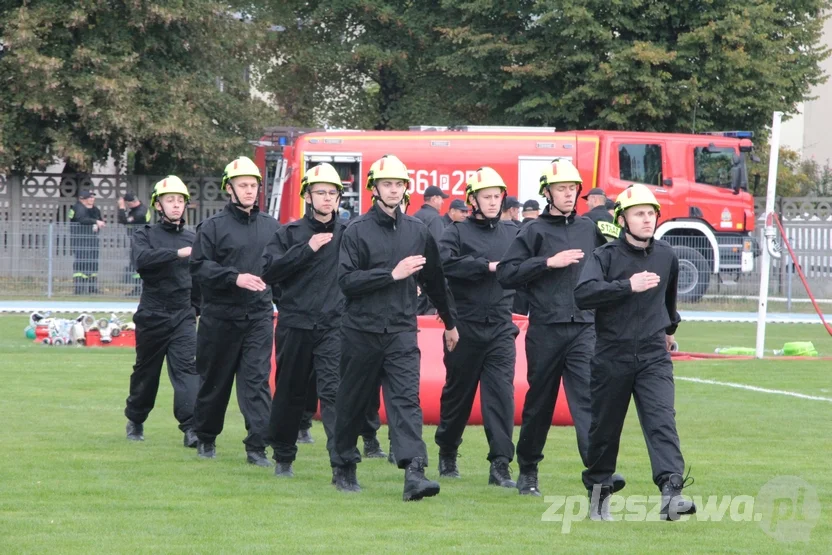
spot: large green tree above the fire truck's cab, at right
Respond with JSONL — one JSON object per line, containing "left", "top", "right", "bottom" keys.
{"left": 441, "top": 0, "right": 831, "bottom": 133}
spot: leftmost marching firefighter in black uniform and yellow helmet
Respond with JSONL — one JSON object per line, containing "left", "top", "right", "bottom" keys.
{"left": 124, "top": 175, "right": 199, "bottom": 447}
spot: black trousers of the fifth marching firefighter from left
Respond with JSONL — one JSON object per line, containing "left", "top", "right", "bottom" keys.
{"left": 435, "top": 321, "right": 519, "bottom": 461}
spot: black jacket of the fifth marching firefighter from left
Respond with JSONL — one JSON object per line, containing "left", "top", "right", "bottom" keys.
{"left": 439, "top": 216, "right": 518, "bottom": 324}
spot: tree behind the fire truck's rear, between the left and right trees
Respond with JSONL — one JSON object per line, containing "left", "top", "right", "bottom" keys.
{"left": 251, "top": 0, "right": 466, "bottom": 129}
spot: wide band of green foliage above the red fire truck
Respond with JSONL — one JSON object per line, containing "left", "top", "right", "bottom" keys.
{"left": 255, "top": 0, "right": 830, "bottom": 132}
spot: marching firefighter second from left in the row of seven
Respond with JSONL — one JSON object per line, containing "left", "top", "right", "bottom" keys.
{"left": 190, "top": 156, "right": 278, "bottom": 467}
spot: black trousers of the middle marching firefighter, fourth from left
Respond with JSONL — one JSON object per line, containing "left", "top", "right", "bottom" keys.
{"left": 330, "top": 327, "right": 427, "bottom": 468}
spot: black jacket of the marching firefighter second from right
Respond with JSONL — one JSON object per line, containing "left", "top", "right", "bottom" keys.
{"left": 497, "top": 212, "right": 606, "bottom": 324}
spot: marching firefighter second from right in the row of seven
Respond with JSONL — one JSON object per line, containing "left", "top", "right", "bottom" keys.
{"left": 497, "top": 159, "right": 623, "bottom": 495}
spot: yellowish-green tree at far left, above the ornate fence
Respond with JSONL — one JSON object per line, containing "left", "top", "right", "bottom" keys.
{"left": 0, "top": 0, "right": 267, "bottom": 174}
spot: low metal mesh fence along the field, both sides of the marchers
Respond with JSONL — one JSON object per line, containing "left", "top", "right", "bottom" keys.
{"left": 0, "top": 221, "right": 832, "bottom": 310}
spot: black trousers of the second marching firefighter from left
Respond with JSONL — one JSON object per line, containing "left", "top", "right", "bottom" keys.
{"left": 194, "top": 315, "right": 274, "bottom": 451}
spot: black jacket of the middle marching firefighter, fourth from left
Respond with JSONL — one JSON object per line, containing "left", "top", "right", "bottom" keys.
{"left": 338, "top": 205, "right": 455, "bottom": 333}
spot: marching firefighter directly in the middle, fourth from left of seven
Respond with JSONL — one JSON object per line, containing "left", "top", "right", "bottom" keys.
{"left": 330, "top": 155, "right": 459, "bottom": 501}
